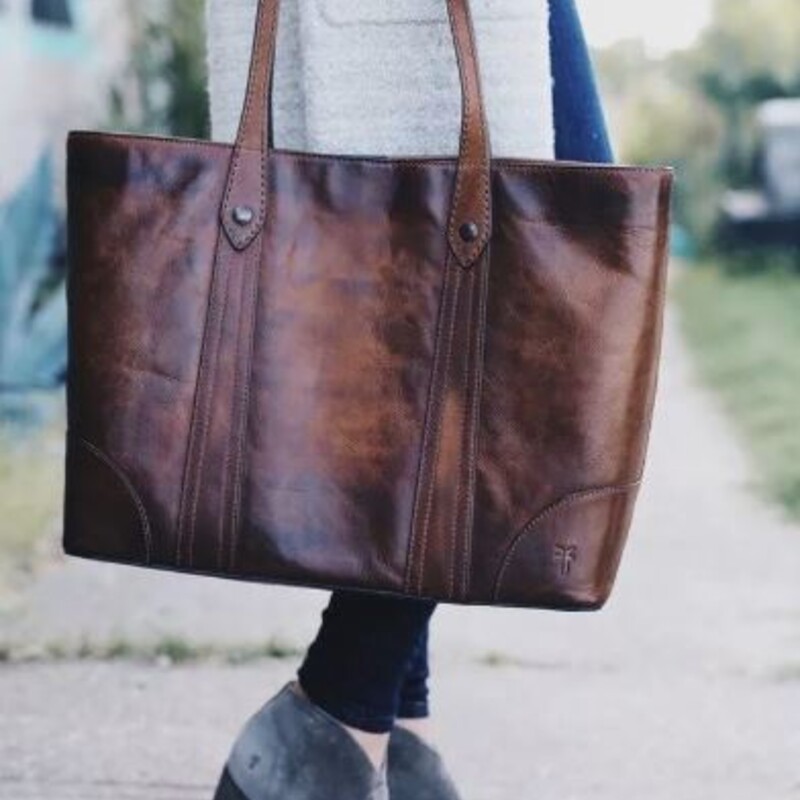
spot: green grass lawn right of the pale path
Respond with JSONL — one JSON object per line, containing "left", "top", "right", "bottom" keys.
{"left": 674, "top": 264, "right": 800, "bottom": 520}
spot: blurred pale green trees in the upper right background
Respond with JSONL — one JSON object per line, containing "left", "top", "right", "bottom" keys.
{"left": 595, "top": 0, "right": 800, "bottom": 248}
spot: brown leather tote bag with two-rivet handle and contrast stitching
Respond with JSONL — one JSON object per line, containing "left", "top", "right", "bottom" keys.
{"left": 63, "top": 0, "right": 672, "bottom": 609}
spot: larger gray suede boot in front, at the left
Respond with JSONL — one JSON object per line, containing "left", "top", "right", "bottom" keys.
{"left": 214, "top": 684, "right": 389, "bottom": 800}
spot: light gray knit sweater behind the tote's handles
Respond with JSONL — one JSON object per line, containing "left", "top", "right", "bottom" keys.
{"left": 206, "top": 0, "right": 554, "bottom": 158}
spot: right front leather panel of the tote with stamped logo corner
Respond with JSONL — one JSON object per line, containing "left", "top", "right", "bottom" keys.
{"left": 472, "top": 168, "right": 670, "bottom": 608}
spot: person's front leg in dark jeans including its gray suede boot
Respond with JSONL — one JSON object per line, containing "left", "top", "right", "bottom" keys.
{"left": 215, "top": 591, "right": 434, "bottom": 800}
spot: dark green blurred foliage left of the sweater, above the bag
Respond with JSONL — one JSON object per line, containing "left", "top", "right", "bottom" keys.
{"left": 111, "top": 0, "right": 210, "bottom": 138}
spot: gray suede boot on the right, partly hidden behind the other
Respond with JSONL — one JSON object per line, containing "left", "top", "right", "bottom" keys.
{"left": 388, "top": 725, "right": 461, "bottom": 800}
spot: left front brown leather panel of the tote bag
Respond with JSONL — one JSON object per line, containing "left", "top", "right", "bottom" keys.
{"left": 64, "top": 134, "right": 228, "bottom": 566}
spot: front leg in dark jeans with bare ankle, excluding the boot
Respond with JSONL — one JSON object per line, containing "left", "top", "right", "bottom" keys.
{"left": 298, "top": 591, "right": 435, "bottom": 762}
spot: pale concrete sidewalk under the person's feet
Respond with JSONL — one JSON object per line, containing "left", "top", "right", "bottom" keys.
{"left": 0, "top": 308, "right": 800, "bottom": 800}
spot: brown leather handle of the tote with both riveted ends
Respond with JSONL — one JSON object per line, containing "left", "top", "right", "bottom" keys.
{"left": 221, "top": 0, "right": 492, "bottom": 268}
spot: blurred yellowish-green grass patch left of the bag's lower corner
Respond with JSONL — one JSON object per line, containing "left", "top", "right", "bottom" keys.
{"left": 0, "top": 425, "right": 64, "bottom": 594}
